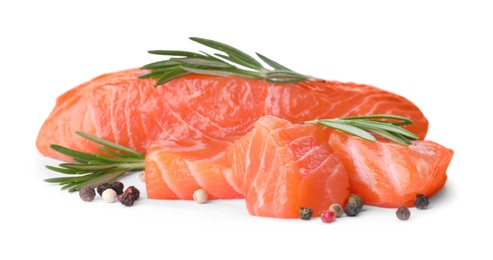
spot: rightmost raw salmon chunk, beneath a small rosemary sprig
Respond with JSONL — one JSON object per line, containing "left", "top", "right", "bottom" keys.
{"left": 330, "top": 131, "right": 453, "bottom": 208}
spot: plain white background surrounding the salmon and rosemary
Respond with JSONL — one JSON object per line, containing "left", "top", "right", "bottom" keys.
{"left": 0, "top": 0, "right": 493, "bottom": 259}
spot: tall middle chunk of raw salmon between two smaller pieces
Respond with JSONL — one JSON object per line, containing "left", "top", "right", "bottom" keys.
{"left": 228, "top": 116, "right": 349, "bottom": 218}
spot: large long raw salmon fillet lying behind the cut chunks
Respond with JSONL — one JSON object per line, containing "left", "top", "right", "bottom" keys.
{"left": 36, "top": 69, "right": 428, "bottom": 160}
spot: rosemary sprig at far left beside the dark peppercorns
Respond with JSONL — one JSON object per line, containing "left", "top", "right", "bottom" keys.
{"left": 45, "top": 132, "right": 145, "bottom": 191}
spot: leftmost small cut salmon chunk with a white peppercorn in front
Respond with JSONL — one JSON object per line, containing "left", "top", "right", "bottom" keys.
{"left": 145, "top": 140, "right": 243, "bottom": 200}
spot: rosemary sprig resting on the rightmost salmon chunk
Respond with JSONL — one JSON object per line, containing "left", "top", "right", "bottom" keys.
{"left": 304, "top": 115, "right": 418, "bottom": 145}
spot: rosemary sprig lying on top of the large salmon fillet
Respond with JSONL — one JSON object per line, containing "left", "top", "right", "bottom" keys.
{"left": 140, "top": 37, "right": 310, "bottom": 86}
